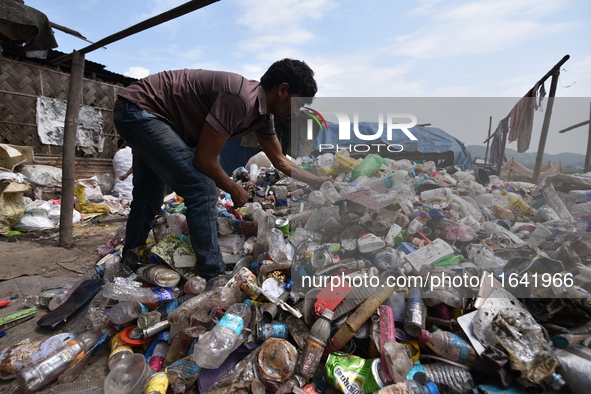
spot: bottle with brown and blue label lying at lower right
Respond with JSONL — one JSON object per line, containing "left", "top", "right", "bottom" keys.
{"left": 418, "top": 329, "right": 478, "bottom": 366}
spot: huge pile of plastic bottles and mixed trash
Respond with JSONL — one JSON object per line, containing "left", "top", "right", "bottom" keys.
{"left": 0, "top": 152, "right": 591, "bottom": 394}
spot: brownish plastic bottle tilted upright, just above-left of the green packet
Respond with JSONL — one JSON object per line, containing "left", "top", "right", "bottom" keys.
{"left": 298, "top": 309, "right": 334, "bottom": 379}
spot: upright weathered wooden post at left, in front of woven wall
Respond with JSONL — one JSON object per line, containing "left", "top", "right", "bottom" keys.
{"left": 59, "top": 51, "right": 84, "bottom": 246}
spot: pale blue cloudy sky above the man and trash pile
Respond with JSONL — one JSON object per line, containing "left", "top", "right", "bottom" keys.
{"left": 25, "top": 0, "right": 591, "bottom": 153}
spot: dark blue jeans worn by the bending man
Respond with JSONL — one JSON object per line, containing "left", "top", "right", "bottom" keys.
{"left": 113, "top": 101, "right": 226, "bottom": 279}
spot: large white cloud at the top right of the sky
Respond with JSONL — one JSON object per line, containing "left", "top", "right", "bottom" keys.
{"left": 392, "top": 0, "right": 568, "bottom": 59}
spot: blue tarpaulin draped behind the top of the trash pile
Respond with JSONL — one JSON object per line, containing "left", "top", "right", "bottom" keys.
{"left": 314, "top": 122, "right": 473, "bottom": 169}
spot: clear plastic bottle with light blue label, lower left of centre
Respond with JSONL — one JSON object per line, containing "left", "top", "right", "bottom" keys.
{"left": 193, "top": 303, "right": 251, "bottom": 369}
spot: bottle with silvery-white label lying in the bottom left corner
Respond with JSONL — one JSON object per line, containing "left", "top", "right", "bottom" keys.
{"left": 16, "top": 340, "right": 82, "bottom": 393}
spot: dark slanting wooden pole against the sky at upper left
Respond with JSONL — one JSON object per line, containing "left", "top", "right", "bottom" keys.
{"left": 53, "top": 0, "right": 219, "bottom": 64}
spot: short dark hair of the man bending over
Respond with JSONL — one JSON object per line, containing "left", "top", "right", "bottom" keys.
{"left": 261, "top": 59, "right": 318, "bottom": 102}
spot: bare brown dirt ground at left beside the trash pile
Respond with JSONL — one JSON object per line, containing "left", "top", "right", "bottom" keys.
{"left": 0, "top": 218, "right": 125, "bottom": 392}
